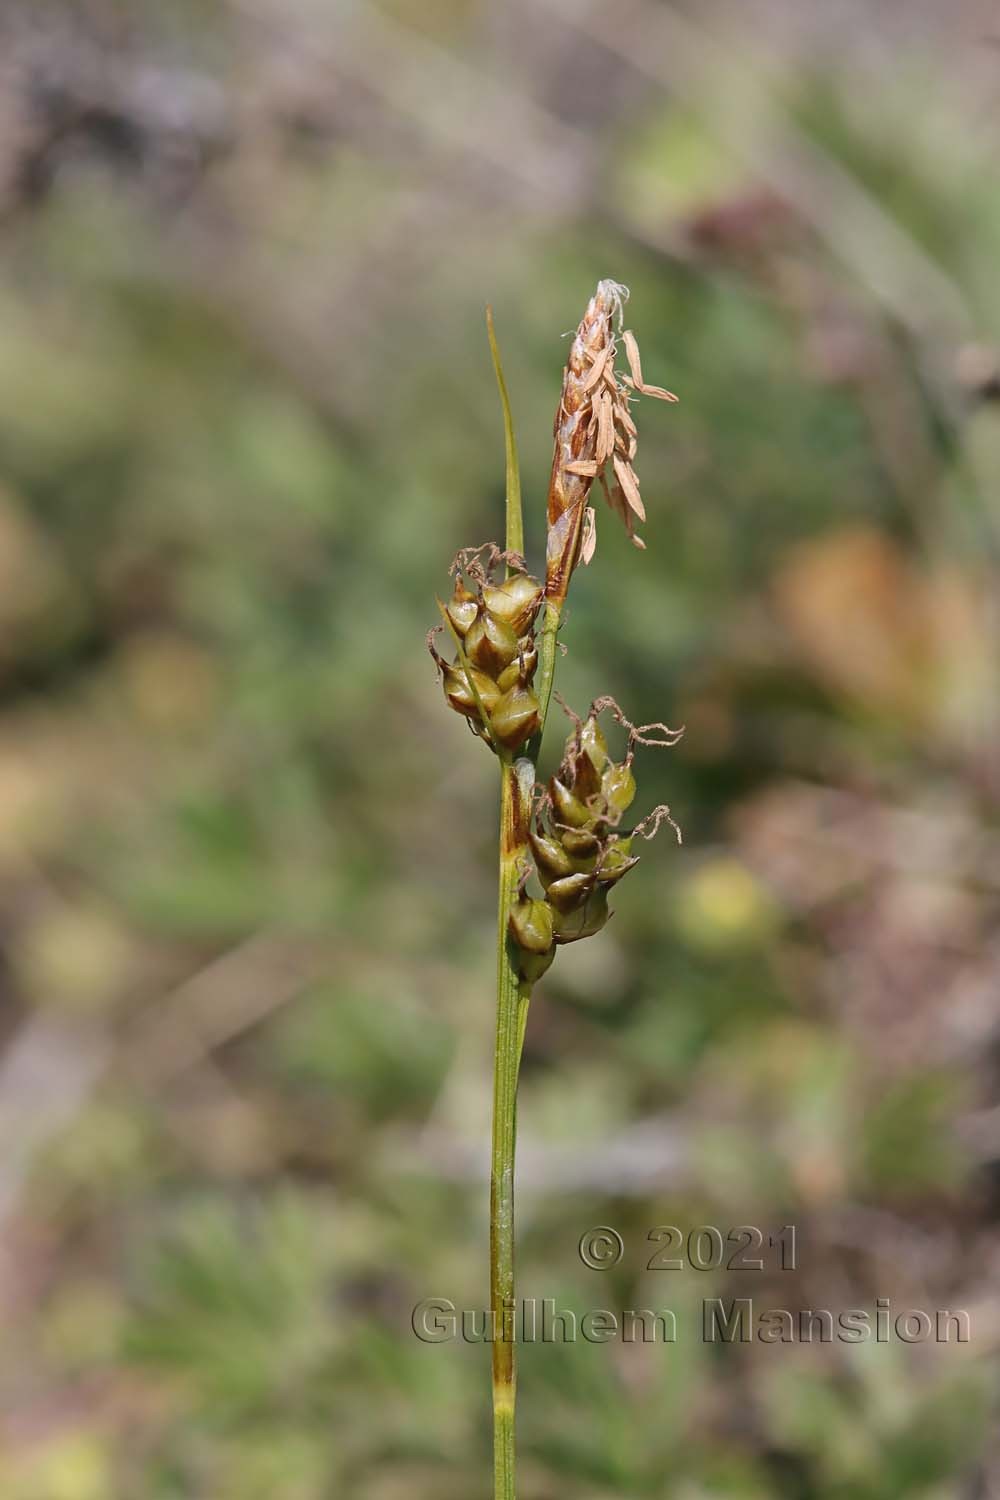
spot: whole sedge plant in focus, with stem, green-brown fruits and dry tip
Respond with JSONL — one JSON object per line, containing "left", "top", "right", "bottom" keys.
{"left": 429, "top": 281, "right": 681, "bottom": 1500}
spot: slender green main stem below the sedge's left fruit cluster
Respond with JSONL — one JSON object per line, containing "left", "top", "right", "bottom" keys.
{"left": 490, "top": 758, "right": 535, "bottom": 1500}
